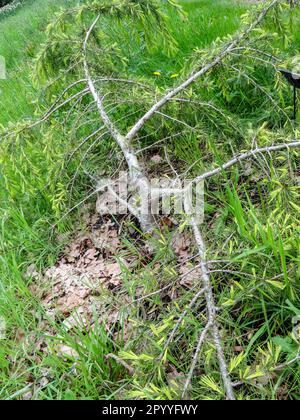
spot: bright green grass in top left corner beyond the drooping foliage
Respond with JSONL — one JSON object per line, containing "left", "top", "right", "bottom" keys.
{"left": 0, "top": 0, "right": 85, "bottom": 125}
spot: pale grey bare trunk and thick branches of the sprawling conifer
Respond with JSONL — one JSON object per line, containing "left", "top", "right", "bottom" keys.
{"left": 78, "top": 0, "right": 300, "bottom": 400}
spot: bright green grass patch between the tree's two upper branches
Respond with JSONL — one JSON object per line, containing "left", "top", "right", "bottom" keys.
{"left": 123, "top": 0, "right": 246, "bottom": 83}
